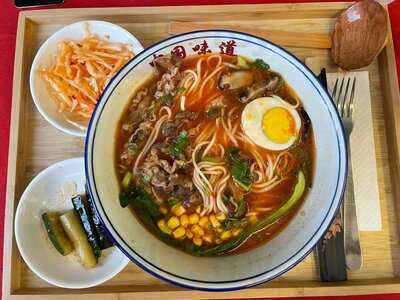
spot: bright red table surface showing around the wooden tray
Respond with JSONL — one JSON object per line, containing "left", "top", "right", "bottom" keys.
{"left": 0, "top": 0, "right": 400, "bottom": 300}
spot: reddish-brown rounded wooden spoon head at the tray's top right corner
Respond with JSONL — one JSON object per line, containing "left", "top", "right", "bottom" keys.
{"left": 332, "top": 0, "right": 388, "bottom": 70}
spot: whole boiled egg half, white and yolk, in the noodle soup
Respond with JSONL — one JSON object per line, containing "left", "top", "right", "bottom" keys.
{"left": 241, "top": 95, "right": 301, "bottom": 151}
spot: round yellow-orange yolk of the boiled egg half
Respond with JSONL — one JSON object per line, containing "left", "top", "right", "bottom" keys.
{"left": 262, "top": 107, "right": 296, "bottom": 144}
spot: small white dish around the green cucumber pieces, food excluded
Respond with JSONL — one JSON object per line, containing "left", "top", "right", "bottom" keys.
{"left": 15, "top": 157, "right": 129, "bottom": 289}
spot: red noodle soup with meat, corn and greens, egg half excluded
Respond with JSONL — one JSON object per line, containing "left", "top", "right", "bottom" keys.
{"left": 115, "top": 54, "right": 315, "bottom": 256}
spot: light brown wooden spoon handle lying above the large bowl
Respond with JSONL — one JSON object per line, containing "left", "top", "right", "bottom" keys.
{"left": 169, "top": 21, "right": 332, "bottom": 49}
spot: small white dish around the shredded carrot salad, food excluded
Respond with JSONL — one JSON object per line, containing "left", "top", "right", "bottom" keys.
{"left": 29, "top": 21, "right": 143, "bottom": 137}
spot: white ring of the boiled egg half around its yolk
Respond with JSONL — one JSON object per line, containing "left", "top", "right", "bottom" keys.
{"left": 241, "top": 95, "right": 301, "bottom": 151}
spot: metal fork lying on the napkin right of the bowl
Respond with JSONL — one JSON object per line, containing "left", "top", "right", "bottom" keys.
{"left": 332, "top": 77, "right": 362, "bottom": 271}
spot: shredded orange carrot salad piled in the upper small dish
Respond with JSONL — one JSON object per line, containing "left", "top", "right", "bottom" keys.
{"left": 39, "top": 35, "right": 134, "bottom": 127}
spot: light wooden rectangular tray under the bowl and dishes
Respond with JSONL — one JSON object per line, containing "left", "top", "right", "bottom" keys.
{"left": 3, "top": 3, "right": 400, "bottom": 300}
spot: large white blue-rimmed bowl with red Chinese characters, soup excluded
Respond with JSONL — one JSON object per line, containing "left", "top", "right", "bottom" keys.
{"left": 85, "top": 30, "right": 347, "bottom": 291}
